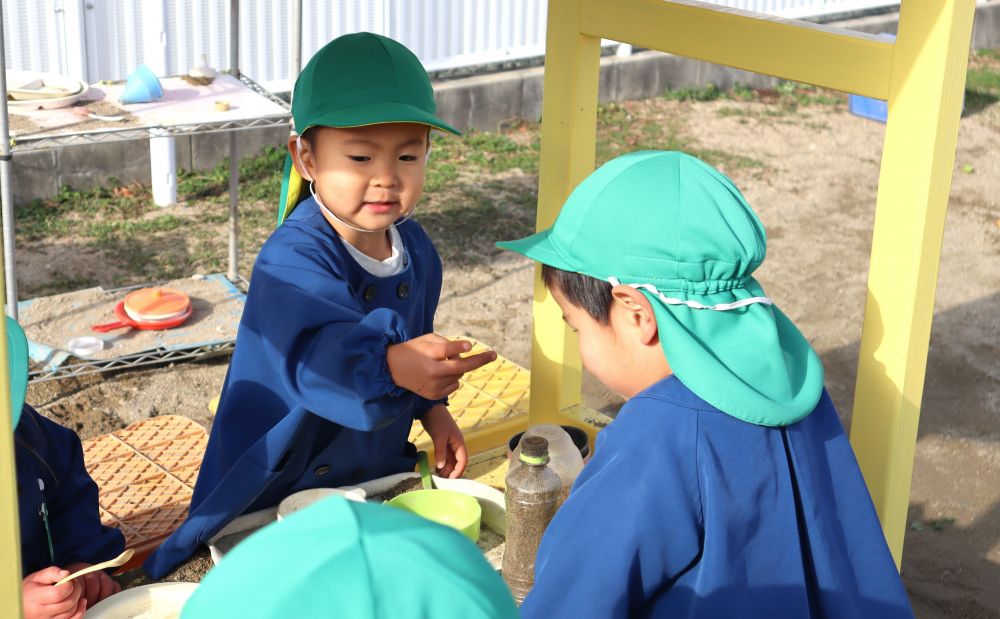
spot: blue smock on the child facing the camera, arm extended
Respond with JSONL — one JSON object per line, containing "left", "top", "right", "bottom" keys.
{"left": 144, "top": 198, "right": 441, "bottom": 578}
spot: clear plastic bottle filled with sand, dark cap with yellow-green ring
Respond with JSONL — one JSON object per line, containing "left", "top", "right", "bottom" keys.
{"left": 502, "top": 436, "right": 563, "bottom": 605}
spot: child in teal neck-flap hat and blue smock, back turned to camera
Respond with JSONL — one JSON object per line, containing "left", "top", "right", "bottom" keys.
{"left": 500, "top": 151, "right": 913, "bottom": 619}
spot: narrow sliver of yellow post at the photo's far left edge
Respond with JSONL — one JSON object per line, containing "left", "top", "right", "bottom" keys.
{"left": 0, "top": 270, "right": 21, "bottom": 617}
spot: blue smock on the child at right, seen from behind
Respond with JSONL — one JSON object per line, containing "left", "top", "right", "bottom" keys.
{"left": 521, "top": 376, "right": 913, "bottom": 619}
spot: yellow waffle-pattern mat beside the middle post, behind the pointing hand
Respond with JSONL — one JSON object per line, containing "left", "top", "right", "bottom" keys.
{"left": 410, "top": 337, "right": 531, "bottom": 445}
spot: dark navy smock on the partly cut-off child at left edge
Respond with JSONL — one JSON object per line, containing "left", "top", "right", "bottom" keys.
{"left": 14, "top": 404, "right": 125, "bottom": 576}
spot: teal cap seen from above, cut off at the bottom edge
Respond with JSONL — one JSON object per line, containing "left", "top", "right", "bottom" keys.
{"left": 181, "top": 496, "right": 518, "bottom": 619}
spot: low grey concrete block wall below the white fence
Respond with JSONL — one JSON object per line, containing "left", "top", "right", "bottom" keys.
{"left": 12, "top": 0, "right": 1000, "bottom": 205}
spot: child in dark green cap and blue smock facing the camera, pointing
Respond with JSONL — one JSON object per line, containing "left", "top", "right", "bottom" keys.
{"left": 145, "top": 33, "right": 496, "bottom": 578}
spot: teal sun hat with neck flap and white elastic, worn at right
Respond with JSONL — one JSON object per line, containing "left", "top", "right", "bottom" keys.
{"left": 497, "top": 151, "right": 823, "bottom": 426}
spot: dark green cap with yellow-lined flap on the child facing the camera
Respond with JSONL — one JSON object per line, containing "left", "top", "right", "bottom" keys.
{"left": 278, "top": 32, "right": 461, "bottom": 223}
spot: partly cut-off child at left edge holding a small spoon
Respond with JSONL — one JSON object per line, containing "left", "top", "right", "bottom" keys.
{"left": 6, "top": 317, "right": 125, "bottom": 619}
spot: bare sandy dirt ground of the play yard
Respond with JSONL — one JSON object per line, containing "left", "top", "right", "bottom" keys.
{"left": 28, "top": 89, "right": 1000, "bottom": 619}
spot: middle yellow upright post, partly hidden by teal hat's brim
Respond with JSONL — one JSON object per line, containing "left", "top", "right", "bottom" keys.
{"left": 529, "top": 0, "right": 601, "bottom": 425}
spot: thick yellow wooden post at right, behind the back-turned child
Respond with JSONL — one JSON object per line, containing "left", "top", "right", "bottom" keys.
{"left": 851, "top": 0, "right": 975, "bottom": 566}
